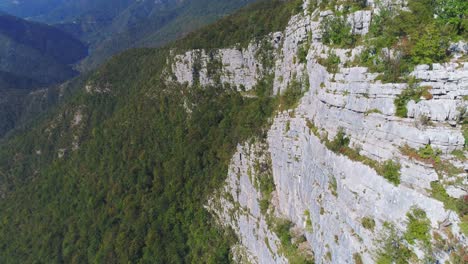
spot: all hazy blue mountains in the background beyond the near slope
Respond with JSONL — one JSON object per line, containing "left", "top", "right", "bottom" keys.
{"left": 0, "top": 0, "right": 253, "bottom": 138}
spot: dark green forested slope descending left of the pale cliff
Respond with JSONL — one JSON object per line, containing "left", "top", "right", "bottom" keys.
{"left": 0, "top": 1, "right": 302, "bottom": 263}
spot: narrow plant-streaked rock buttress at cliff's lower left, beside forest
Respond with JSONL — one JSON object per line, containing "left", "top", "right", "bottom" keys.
{"left": 210, "top": 143, "right": 287, "bottom": 263}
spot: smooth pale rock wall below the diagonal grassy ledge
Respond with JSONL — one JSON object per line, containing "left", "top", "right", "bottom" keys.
{"left": 268, "top": 113, "right": 452, "bottom": 263}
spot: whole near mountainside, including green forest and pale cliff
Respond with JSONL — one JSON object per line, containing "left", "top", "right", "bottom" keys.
{"left": 0, "top": 0, "right": 468, "bottom": 263}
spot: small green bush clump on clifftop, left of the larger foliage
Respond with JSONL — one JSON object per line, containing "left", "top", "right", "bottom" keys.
{"left": 322, "top": 16, "right": 356, "bottom": 47}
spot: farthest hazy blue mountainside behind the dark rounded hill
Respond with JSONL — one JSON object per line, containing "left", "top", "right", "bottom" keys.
{"left": 0, "top": 0, "right": 253, "bottom": 70}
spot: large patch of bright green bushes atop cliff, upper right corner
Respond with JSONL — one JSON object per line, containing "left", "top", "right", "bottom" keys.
{"left": 361, "top": 0, "right": 467, "bottom": 82}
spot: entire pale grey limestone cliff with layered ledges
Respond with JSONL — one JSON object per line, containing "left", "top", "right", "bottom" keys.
{"left": 171, "top": 1, "right": 468, "bottom": 263}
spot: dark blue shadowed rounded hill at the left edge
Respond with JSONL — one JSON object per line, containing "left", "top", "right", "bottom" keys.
{"left": 0, "top": 13, "right": 88, "bottom": 138}
